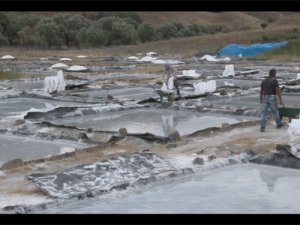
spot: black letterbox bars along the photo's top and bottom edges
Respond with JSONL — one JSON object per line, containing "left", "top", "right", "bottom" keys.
{"left": 0, "top": 0, "right": 300, "bottom": 224}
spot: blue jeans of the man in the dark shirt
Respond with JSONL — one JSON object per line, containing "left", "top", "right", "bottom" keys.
{"left": 260, "top": 95, "right": 281, "bottom": 127}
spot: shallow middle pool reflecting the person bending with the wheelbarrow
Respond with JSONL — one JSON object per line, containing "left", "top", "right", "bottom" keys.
{"left": 51, "top": 109, "right": 257, "bottom": 136}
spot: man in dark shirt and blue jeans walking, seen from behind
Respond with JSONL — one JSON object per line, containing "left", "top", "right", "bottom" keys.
{"left": 260, "top": 69, "right": 283, "bottom": 132}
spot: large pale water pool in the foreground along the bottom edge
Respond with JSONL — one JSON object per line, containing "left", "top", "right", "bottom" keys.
{"left": 38, "top": 164, "right": 300, "bottom": 214}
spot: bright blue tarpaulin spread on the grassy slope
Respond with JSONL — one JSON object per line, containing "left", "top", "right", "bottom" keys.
{"left": 218, "top": 41, "right": 288, "bottom": 57}
